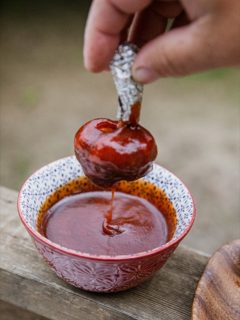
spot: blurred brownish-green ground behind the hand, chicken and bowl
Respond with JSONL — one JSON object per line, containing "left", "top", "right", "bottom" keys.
{"left": 0, "top": 0, "right": 240, "bottom": 253}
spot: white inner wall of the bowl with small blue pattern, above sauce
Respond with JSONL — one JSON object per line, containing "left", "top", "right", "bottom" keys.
{"left": 19, "top": 156, "right": 194, "bottom": 245}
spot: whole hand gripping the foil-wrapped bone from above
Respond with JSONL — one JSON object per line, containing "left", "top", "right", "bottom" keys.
{"left": 84, "top": 0, "right": 240, "bottom": 83}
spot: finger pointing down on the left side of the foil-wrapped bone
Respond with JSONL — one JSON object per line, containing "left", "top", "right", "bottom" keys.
{"left": 84, "top": 0, "right": 151, "bottom": 72}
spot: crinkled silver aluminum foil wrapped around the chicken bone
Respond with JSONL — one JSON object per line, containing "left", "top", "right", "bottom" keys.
{"left": 110, "top": 43, "right": 143, "bottom": 121}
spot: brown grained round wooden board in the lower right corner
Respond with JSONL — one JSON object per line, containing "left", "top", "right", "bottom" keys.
{"left": 192, "top": 240, "right": 240, "bottom": 320}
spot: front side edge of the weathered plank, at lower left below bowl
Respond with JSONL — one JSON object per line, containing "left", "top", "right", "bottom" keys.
{"left": 0, "top": 269, "right": 136, "bottom": 320}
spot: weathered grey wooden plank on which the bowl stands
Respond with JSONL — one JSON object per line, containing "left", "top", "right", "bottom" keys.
{"left": 0, "top": 188, "right": 208, "bottom": 320}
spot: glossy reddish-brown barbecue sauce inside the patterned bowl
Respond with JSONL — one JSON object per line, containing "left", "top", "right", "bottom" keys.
{"left": 37, "top": 177, "right": 176, "bottom": 256}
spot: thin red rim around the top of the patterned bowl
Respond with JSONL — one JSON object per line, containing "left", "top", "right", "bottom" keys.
{"left": 17, "top": 157, "right": 196, "bottom": 262}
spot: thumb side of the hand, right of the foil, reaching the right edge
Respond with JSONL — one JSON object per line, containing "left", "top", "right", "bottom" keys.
{"left": 132, "top": 0, "right": 240, "bottom": 83}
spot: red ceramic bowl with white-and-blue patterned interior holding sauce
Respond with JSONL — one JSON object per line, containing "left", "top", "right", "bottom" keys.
{"left": 18, "top": 156, "right": 196, "bottom": 292}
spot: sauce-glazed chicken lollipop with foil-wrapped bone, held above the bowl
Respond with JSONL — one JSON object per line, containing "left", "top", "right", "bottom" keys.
{"left": 74, "top": 43, "right": 157, "bottom": 187}
